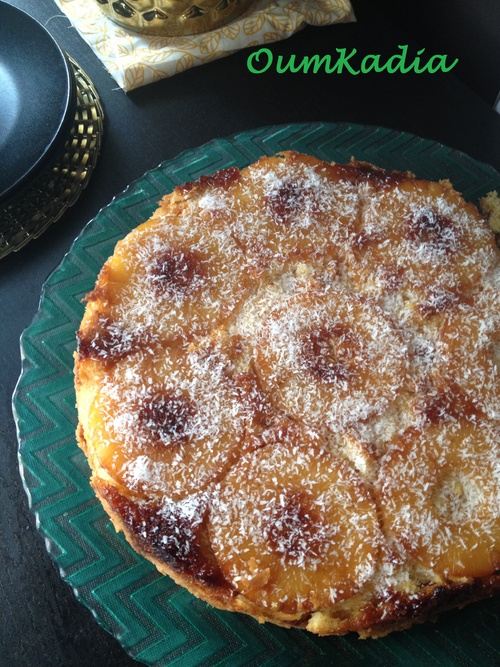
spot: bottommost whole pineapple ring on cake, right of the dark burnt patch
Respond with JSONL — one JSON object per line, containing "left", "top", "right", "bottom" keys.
{"left": 209, "top": 427, "right": 381, "bottom": 614}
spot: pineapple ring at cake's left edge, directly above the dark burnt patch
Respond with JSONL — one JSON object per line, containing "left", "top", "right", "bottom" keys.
{"left": 84, "top": 348, "right": 255, "bottom": 500}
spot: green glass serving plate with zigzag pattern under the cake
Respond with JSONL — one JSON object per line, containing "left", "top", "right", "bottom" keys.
{"left": 13, "top": 123, "right": 500, "bottom": 667}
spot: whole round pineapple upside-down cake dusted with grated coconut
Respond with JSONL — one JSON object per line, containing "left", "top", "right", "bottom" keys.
{"left": 75, "top": 152, "right": 500, "bottom": 637}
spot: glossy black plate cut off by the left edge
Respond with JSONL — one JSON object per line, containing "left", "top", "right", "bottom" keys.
{"left": 0, "top": 0, "right": 76, "bottom": 202}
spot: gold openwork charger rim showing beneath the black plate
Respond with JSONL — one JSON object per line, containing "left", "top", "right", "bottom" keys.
{"left": 0, "top": 56, "right": 104, "bottom": 258}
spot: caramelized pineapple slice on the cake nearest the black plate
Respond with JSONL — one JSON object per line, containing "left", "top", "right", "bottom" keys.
{"left": 83, "top": 205, "right": 255, "bottom": 342}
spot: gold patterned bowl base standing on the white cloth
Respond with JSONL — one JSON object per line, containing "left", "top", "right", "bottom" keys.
{"left": 96, "top": 0, "right": 253, "bottom": 37}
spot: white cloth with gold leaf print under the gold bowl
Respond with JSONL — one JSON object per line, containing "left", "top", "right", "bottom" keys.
{"left": 52, "top": 0, "right": 356, "bottom": 91}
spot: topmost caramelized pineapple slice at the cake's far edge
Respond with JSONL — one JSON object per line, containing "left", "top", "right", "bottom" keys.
{"left": 201, "top": 151, "right": 360, "bottom": 269}
